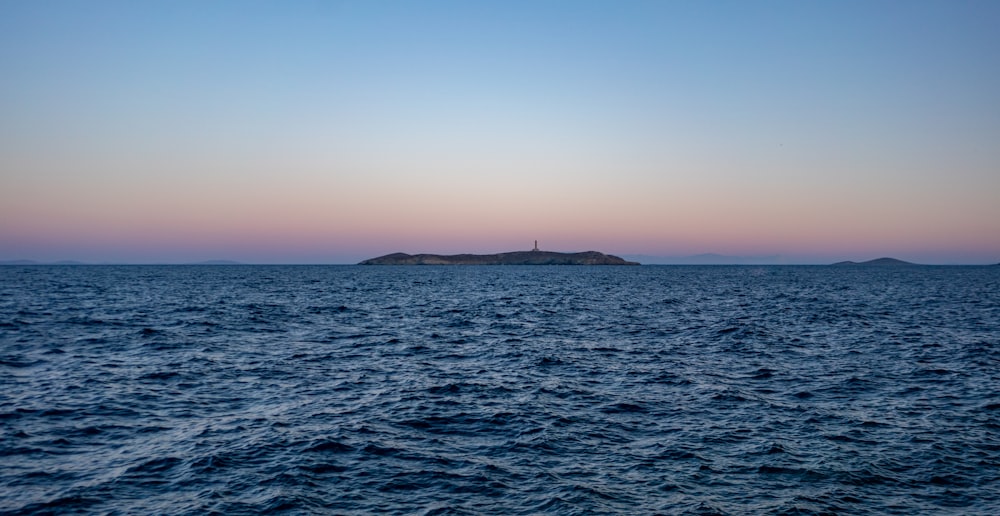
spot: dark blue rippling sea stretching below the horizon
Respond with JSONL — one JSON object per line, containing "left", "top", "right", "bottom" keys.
{"left": 0, "top": 265, "right": 1000, "bottom": 515}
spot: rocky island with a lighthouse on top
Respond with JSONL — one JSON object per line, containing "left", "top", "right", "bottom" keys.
{"left": 360, "top": 242, "right": 639, "bottom": 265}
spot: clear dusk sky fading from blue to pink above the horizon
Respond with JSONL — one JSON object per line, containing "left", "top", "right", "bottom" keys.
{"left": 0, "top": 0, "right": 1000, "bottom": 264}
